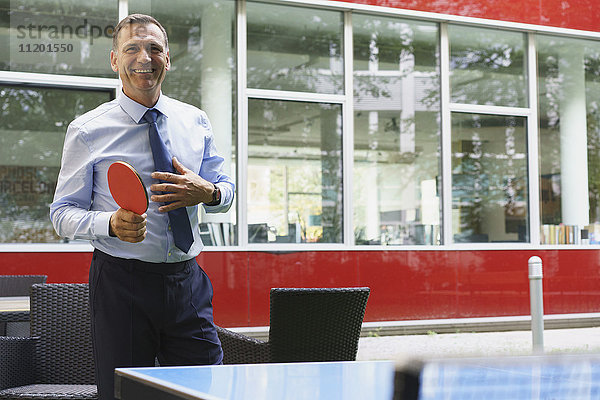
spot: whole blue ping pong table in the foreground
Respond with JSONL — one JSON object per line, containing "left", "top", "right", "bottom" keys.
{"left": 115, "top": 354, "right": 600, "bottom": 400}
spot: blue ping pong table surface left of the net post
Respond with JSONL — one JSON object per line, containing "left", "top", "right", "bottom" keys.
{"left": 117, "top": 361, "right": 395, "bottom": 400}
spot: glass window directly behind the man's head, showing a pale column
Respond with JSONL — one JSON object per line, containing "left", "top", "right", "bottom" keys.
{"left": 129, "top": 0, "right": 237, "bottom": 246}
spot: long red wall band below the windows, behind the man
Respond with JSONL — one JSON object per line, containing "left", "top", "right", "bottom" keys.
{"left": 0, "top": 249, "right": 600, "bottom": 326}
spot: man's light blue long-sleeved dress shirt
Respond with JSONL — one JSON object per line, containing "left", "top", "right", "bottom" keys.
{"left": 50, "top": 91, "right": 235, "bottom": 262}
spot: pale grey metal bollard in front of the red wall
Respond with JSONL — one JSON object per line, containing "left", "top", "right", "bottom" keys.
{"left": 529, "top": 256, "right": 544, "bottom": 353}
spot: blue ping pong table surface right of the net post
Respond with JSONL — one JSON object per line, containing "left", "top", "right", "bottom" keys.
{"left": 419, "top": 354, "right": 600, "bottom": 400}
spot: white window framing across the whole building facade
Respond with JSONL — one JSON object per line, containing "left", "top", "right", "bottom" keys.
{"left": 0, "top": 0, "right": 600, "bottom": 252}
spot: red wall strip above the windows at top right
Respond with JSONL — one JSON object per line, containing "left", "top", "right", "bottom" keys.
{"left": 330, "top": 0, "right": 600, "bottom": 31}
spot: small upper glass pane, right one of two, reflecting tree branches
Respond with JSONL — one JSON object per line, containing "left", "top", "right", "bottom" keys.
{"left": 448, "top": 25, "right": 527, "bottom": 107}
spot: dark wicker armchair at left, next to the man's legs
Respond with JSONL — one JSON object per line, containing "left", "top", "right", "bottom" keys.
{"left": 0, "top": 284, "right": 98, "bottom": 399}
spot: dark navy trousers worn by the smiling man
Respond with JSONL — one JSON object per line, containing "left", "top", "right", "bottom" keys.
{"left": 90, "top": 250, "right": 223, "bottom": 400}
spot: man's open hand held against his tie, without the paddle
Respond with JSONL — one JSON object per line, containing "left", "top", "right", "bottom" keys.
{"left": 150, "top": 157, "right": 214, "bottom": 212}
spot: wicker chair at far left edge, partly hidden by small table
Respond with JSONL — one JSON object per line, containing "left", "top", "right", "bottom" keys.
{"left": 0, "top": 275, "right": 48, "bottom": 336}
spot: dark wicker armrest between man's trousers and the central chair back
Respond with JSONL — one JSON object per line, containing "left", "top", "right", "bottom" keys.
{"left": 217, "top": 326, "right": 271, "bottom": 364}
